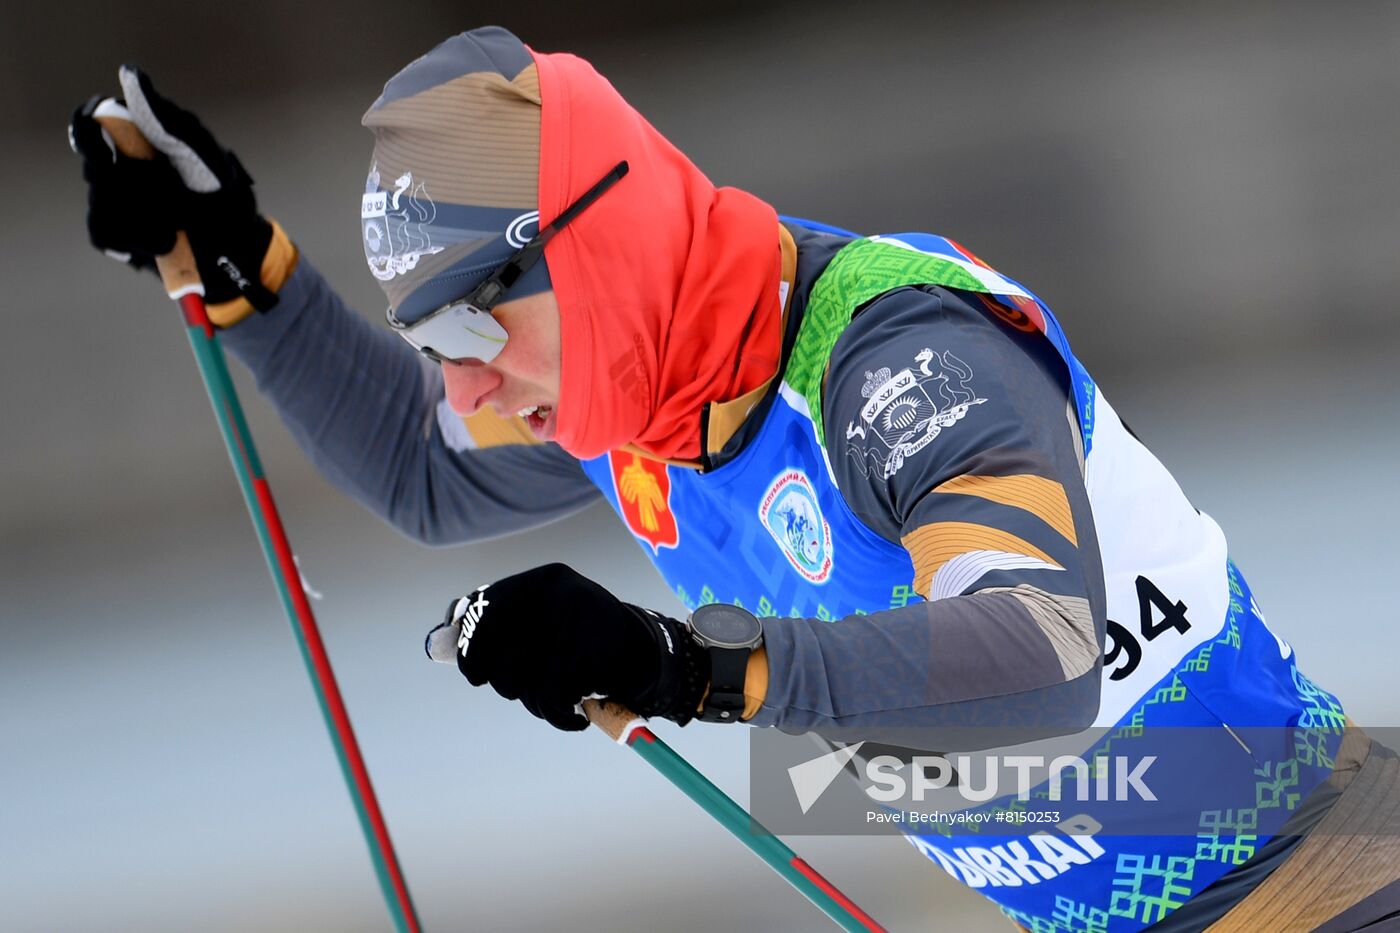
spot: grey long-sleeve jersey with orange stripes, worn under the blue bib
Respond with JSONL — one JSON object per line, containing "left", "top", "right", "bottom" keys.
{"left": 223, "top": 231, "right": 1103, "bottom": 731}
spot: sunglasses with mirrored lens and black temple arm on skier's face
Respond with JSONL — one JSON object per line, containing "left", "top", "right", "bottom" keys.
{"left": 385, "top": 163, "right": 627, "bottom": 363}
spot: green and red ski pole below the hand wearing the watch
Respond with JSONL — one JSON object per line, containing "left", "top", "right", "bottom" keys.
{"left": 584, "top": 699, "right": 885, "bottom": 933}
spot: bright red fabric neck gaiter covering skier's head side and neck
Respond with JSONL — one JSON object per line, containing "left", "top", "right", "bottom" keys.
{"left": 532, "top": 50, "right": 781, "bottom": 459}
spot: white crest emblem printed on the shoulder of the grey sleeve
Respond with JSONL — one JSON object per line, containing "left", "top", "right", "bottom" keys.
{"left": 846, "top": 347, "right": 987, "bottom": 479}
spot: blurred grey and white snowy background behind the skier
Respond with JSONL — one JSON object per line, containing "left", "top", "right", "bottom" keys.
{"left": 0, "top": 0, "right": 1400, "bottom": 932}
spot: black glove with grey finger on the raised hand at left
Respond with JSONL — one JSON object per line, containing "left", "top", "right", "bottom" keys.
{"left": 69, "top": 66, "right": 277, "bottom": 311}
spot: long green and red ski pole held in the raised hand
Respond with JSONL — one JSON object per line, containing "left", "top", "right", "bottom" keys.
{"left": 95, "top": 101, "right": 420, "bottom": 933}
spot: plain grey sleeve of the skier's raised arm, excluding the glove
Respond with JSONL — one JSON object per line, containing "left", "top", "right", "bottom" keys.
{"left": 221, "top": 256, "right": 598, "bottom": 545}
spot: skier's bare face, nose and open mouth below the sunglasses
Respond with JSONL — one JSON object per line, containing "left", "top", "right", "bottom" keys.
{"left": 442, "top": 291, "right": 560, "bottom": 440}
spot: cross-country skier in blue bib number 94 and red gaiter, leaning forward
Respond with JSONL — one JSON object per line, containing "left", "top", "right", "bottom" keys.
{"left": 71, "top": 28, "right": 1400, "bottom": 933}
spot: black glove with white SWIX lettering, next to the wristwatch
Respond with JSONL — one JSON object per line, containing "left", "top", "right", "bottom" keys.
{"left": 424, "top": 563, "right": 710, "bottom": 731}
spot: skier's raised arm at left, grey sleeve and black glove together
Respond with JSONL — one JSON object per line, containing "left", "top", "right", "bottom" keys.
{"left": 69, "top": 76, "right": 598, "bottom": 544}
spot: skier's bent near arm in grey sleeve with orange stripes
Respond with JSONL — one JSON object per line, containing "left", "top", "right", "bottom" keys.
{"left": 746, "top": 282, "right": 1105, "bottom": 734}
